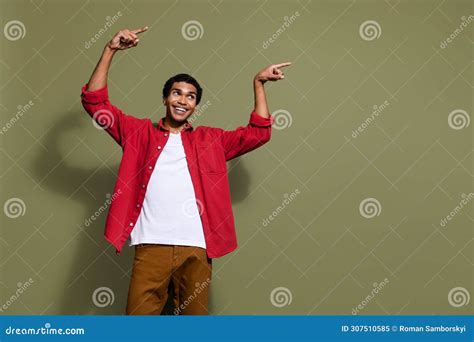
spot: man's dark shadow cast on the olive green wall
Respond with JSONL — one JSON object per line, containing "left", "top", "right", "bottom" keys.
{"left": 32, "top": 112, "right": 250, "bottom": 315}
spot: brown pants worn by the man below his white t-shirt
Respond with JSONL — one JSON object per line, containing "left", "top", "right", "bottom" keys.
{"left": 126, "top": 244, "right": 212, "bottom": 315}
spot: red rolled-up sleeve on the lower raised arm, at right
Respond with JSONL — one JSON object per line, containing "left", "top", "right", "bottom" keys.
{"left": 221, "top": 111, "right": 274, "bottom": 160}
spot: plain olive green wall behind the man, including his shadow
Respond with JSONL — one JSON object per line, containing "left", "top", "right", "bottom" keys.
{"left": 0, "top": 0, "right": 474, "bottom": 315}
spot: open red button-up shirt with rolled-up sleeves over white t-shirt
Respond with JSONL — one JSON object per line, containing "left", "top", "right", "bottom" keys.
{"left": 81, "top": 84, "right": 274, "bottom": 258}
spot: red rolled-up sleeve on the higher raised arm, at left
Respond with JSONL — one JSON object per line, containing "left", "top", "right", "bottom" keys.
{"left": 81, "top": 84, "right": 139, "bottom": 147}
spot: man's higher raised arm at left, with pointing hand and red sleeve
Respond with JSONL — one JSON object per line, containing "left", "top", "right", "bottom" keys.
{"left": 81, "top": 27, "right": 148, "bottom": 147}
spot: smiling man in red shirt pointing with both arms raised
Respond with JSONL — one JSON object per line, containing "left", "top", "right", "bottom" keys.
{"left": 81, "top": 27, "right": 291, "bottom": 315}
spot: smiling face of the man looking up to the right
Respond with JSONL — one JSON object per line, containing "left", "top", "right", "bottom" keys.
{"left": 163, "top": 82, "right": 197, "bottom": 123}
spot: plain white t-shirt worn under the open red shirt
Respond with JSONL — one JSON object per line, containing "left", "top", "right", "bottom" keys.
{"left": 129, "top": 133, "right": 206, "bottom": 248}
